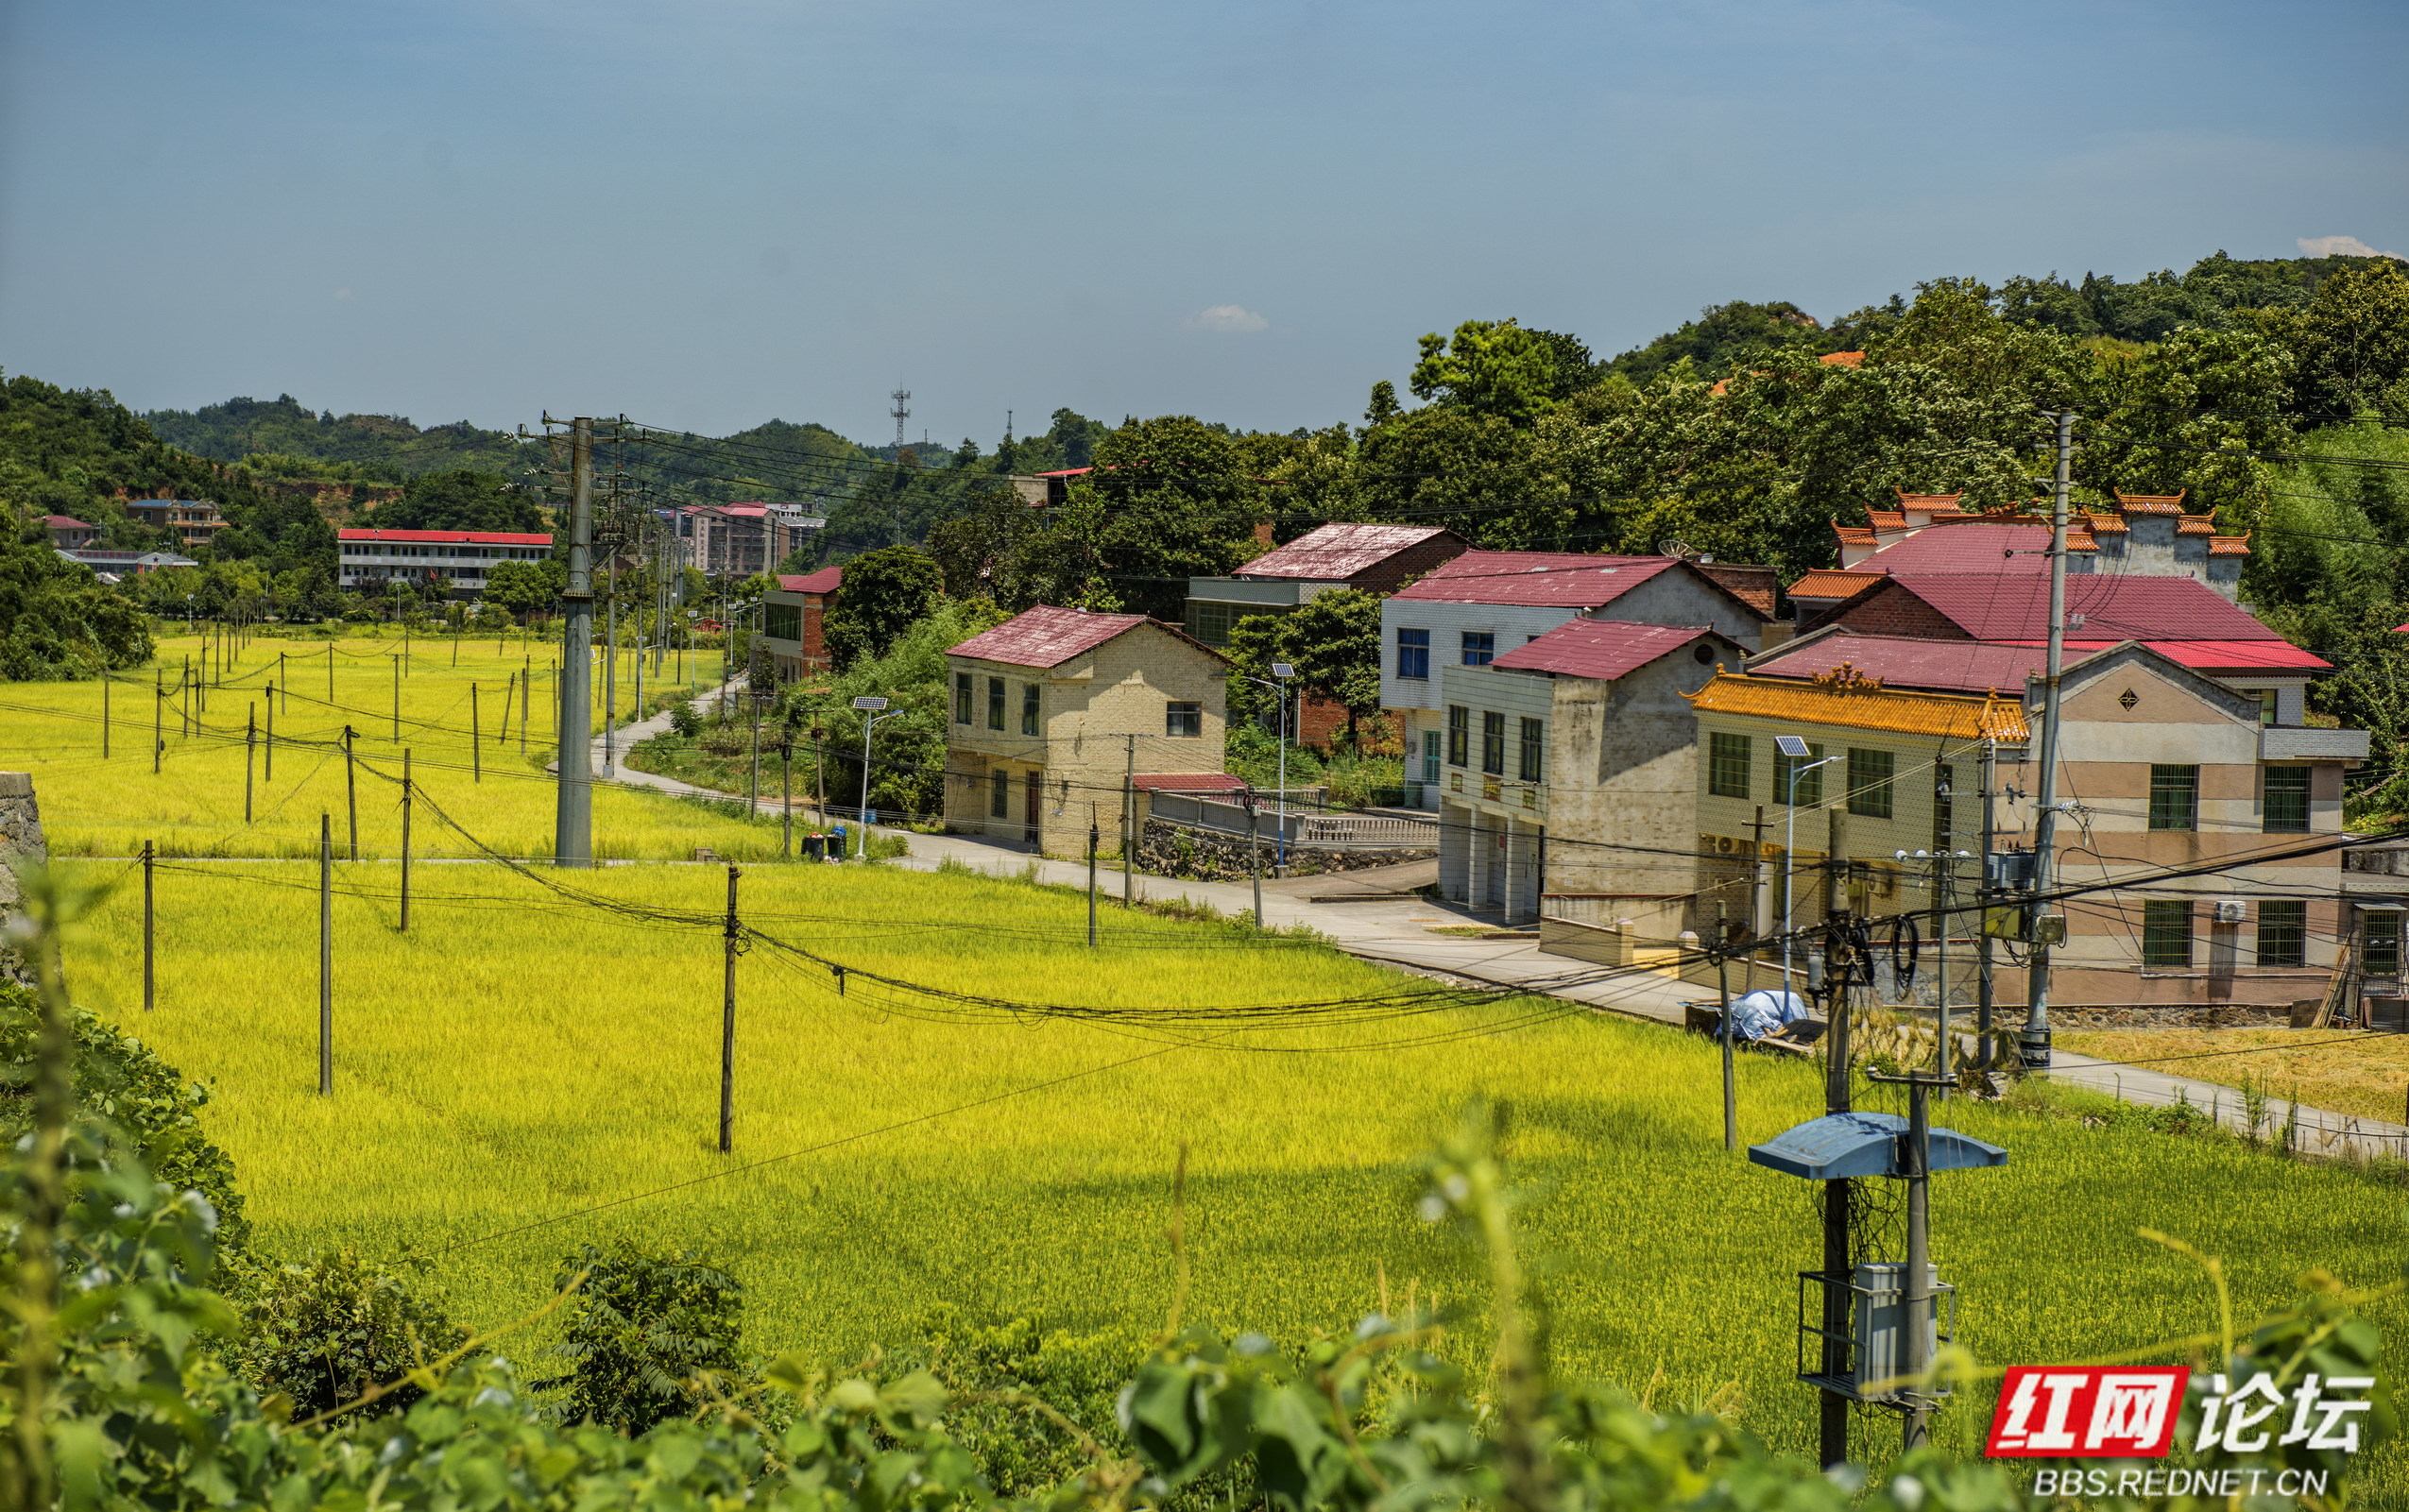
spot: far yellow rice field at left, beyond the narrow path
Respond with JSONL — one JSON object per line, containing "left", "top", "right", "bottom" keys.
{"left": 0, "top": 633, "right": 809, "bottom": 859}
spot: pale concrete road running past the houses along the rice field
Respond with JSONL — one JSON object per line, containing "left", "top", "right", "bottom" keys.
{"left": 595, "top": 703, "right": 2409, "bottom": 1158}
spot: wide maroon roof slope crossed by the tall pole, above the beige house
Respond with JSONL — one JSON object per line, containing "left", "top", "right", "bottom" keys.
{"left": 1891, "top": 573, "right": 2283, "bottom": 643}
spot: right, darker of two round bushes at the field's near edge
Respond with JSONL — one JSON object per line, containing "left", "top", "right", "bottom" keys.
{"left": 555, "top": 1240, "right": 744, "bottom": 1437}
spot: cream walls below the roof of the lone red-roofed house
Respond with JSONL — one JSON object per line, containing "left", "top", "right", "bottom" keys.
{"left": 945, "top": 626, "right": 1229, "bottom": 855}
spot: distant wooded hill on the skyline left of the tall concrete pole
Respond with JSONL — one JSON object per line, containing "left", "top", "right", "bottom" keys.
{"left": 142, "top": 395, "right": 527, "bottom": 484}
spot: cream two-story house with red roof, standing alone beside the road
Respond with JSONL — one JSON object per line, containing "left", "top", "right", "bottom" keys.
{"left": 945, "top": 604, "right": 1229, "bottom": 855}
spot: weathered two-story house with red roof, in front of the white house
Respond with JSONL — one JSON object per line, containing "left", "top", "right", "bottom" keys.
{"left": 1436, "top": 619, "right": 1747, "bottom": 929}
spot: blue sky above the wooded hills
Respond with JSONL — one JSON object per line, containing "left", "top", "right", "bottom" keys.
{"left": 0, "top": 0, "right": 2409, "bottom": 446}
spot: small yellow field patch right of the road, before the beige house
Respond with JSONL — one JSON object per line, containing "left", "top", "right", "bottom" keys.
{"left": 2058, "top": 1028, "right": 2409, "bottom": 1125}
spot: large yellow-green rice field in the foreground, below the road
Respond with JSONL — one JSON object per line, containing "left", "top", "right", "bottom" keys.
{"left": 46, "top": 862, "right": 2404, "bottom": 1483}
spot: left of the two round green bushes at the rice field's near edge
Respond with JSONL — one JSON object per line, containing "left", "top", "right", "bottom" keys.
{"left": 236, "top": 1249, "right": 468, "bottom": 1416}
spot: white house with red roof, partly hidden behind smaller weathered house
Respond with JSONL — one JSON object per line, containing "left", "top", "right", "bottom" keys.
{"left": 1380, "top": 552, "right": 1773, "bottom": 809}
